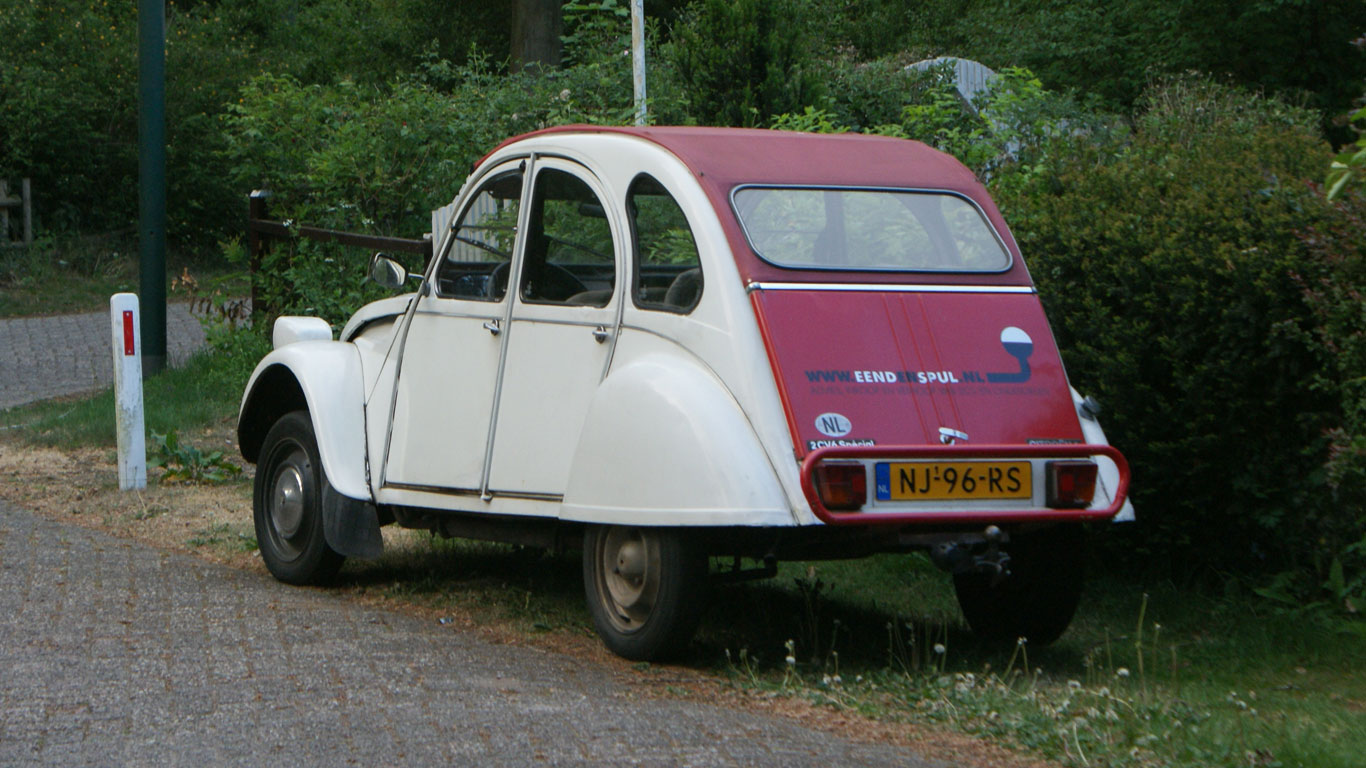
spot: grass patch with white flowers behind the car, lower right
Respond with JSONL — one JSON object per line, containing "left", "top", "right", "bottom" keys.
{"left": 723, "top": 555, "right": 1366, "bottom": 767}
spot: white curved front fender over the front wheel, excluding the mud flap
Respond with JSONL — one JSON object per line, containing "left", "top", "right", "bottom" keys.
{"left": 238, "top": 340, "right": 372, "bottom": 502}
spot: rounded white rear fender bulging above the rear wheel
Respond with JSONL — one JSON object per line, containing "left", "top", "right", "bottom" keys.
{"left": 560, "top": 353, "right": 796, "bottom": 526}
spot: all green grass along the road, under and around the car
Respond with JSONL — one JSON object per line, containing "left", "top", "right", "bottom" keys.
{"left": 3, "top": 333, "right": 1366, "bottom": 768}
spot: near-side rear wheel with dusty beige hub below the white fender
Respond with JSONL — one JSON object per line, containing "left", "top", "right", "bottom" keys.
{"left": 583, "top": 526, "right": 708, "bottom": 661}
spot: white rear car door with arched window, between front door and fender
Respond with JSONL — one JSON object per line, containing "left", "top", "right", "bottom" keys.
{"left": 486, "top": 159, "right": 623, "bottom": 502}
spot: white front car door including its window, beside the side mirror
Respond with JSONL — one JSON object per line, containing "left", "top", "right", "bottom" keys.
{"left": 382, "top": 161, "right": 526, "bottom": 496}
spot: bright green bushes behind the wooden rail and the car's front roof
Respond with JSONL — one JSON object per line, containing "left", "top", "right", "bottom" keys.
{"left": 228, "top": 41, "right": 647, "bottom": 324}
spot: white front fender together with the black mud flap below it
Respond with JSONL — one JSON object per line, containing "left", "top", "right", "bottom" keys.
{"left": 238, "top": 340, "right": 382, "bottom": 558}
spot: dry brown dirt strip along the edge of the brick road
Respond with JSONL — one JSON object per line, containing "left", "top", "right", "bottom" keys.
{"left": 0, "top": 425, "right": 1053, "bottom": 768}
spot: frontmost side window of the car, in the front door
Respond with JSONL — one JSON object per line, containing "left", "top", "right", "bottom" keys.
{"left": 436, "top": 171, "right": 522, "bottom": 302}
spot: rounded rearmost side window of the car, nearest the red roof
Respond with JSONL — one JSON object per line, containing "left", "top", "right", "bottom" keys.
{"left": 626, "top": 174, "right": 702, "bottom": 314}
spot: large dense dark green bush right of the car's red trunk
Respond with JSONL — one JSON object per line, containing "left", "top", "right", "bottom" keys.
{"left": 993, "top": 79, "right": 1340, "bottom": 574}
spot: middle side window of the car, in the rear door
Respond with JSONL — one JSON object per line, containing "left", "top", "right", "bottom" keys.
{"left": 520, "top": 168, "right": 616, "bottom": 306}
